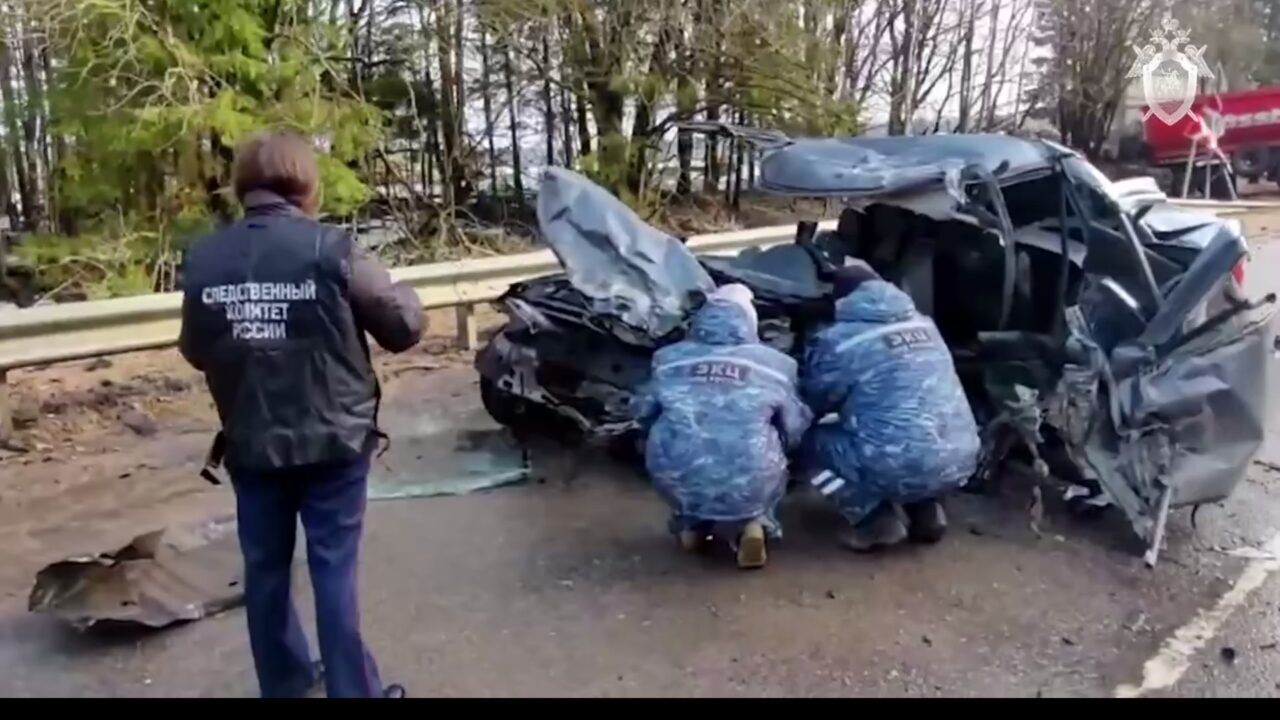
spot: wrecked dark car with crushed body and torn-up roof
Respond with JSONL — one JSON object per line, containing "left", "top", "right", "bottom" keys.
{"left": 476, "top": 134, "right": 1275, "bottom": 562}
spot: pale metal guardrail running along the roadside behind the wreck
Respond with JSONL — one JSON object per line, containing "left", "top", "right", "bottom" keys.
{"left": 0, "top": 194, "right": 1280, "bottom": 430}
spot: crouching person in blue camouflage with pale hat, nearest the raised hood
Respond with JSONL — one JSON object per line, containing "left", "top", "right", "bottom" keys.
{"left": 637, "top": 286, "right": 810, "bottom": 568}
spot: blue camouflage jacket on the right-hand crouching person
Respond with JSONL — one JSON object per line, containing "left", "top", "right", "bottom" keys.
{"left": 801, "top": 281, "right": 979, "bottom": 487}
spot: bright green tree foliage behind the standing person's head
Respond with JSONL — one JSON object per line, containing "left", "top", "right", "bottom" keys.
{"left": 13, "top": 0, "right": 384, "bottom": 296}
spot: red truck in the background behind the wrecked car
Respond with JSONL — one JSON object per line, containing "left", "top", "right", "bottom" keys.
{"left": 1142, "top": 87, "right": 1280, "bottom": 197}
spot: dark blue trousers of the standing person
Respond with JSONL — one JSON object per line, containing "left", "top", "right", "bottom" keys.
{"left": 232, "top": 456, "right": 383, "bottom": 697}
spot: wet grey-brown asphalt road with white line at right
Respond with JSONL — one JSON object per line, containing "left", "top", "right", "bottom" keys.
{"left": 0, "top": 238, "right": 1280, "bottom": 697}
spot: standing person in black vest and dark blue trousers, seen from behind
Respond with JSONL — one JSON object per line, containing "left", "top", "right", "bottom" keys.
{"left": 179, "top": 132, "right": 422, "bottom": 697}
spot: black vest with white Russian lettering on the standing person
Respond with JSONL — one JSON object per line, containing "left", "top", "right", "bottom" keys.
{"left": 183, "top": 205, "right": 379, "bottom": 471}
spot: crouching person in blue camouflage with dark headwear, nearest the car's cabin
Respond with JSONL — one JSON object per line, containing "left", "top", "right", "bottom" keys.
{"left": 801, "top": 264, "right": 979, "bottom": 551}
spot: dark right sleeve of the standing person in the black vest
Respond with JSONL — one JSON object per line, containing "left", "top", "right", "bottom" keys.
{"left": 348, "top": 247, "right": 426, "bottom": 352}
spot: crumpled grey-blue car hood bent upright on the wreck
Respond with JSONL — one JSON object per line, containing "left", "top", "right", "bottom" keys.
{"left": 527, "top": 168, "right": 716, "bottom": 338}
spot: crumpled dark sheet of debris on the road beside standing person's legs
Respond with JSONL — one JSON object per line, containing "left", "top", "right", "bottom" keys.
{"left": 27, "top": 518, "right": 244, "bottom": 630}
